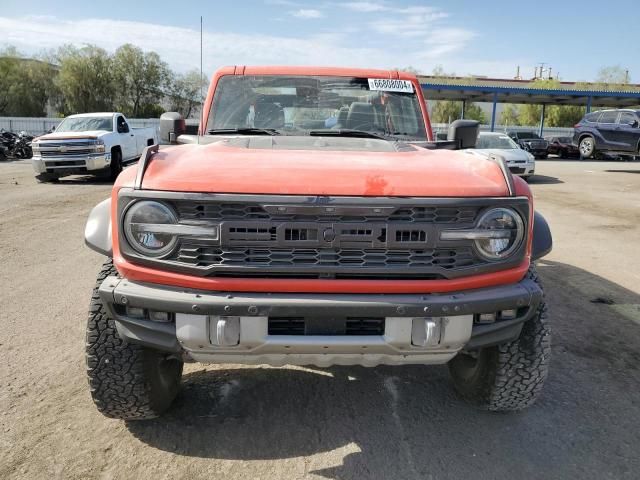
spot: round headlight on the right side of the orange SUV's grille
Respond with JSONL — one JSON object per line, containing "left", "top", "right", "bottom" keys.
{"left": 475, "top": 208, "right": 524, "bottom": 260}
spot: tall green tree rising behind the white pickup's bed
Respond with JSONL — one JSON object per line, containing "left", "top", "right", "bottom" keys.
{"left": 113, "top": 44, "right": 170, "bottom": 117}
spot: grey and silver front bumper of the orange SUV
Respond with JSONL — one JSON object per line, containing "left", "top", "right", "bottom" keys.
{"left": 100, "top": 277, "right": 542, "bottom": 366}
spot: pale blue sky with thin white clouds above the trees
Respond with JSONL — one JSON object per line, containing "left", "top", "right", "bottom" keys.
{"left": 0, "top": 0, "right": 640, "bottom": 83}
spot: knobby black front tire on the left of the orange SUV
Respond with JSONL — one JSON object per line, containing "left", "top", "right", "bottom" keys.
{"left": 86, "top": 260, "right": 183, "bottom": 420}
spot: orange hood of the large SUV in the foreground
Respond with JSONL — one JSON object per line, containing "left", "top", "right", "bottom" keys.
{"left": 142, "top": 137, "right": 509, "bottom": 197}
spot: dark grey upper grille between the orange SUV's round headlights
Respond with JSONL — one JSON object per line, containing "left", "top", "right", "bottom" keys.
{"left": 119, "top": 192, "right": 528, "bottom": 279}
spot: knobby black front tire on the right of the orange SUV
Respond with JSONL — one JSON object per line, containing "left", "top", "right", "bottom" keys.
{"left": 449, "top": 267, "right": 551, "bottom": 411}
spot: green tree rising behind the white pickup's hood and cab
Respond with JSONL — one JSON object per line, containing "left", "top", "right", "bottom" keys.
{"left": 56, "top": 45, "right": 116, "bottom": 115}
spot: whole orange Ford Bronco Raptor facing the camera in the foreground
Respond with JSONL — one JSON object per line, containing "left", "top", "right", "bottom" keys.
{"left": 85, "top": 67, "right": 551, "bottom": 419}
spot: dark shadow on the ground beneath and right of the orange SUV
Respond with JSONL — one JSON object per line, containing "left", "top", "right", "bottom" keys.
{"left": 127, "top": 262, "right": 640, "bottom": 480}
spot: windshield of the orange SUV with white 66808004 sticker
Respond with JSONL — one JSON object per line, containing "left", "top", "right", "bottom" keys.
{"left": 207, "top": 75, "right": 427, "bottom": 140}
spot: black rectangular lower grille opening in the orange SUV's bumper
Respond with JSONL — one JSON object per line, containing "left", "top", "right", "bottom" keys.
{"left": 267, "top": 317, "right": 385, "bottom": 336}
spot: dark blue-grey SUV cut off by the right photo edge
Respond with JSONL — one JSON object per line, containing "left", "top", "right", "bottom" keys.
{"left": 573, "top": 110, "right": 640, "bottom": 158}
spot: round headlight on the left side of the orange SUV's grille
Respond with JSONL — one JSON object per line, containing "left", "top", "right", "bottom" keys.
{"left": 123, "top": 200, "right": 178, "bottom": 257}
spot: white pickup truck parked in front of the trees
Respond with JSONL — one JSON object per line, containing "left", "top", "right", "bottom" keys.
{"left": 32, "top": 112, "right": 158, "bottom": 182}
